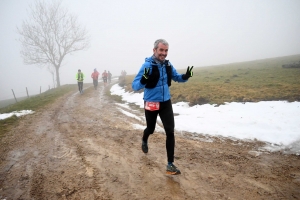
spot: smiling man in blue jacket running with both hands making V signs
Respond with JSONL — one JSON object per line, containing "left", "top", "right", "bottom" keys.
{"left": 132, "top": 39, "right": 193, "bottom": 175}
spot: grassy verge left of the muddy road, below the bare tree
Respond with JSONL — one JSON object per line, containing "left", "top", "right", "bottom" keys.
{"left": 0, "top": 85, "right": 77, "bottom": 138}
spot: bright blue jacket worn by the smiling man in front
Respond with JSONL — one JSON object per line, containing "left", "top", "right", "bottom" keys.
{"left": 132, "top": 56, "right": 187, "bottom": 102}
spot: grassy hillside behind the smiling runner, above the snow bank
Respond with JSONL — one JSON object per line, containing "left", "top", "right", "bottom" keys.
{"left": 122, "top": 55, "right": 300, "bottom": 105}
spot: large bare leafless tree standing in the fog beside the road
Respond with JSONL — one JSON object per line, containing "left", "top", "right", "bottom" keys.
{"left": 17, "top": 1, "right": 89, "bottom": 87}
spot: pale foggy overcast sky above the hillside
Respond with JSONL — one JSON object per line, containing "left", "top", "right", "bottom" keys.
{"left": 0, "top": 0, "right": 300, "bottom": 100}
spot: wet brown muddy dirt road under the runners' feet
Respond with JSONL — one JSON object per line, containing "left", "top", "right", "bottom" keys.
{"left": 0, "top": 83, "right": 300, "bottom": 200}
